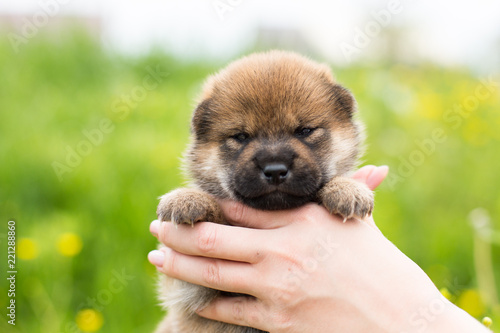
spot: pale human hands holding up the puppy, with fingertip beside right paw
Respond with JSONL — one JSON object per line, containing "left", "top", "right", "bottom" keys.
{"left": 150, "top": 166, "right": 488, "bottom": 333}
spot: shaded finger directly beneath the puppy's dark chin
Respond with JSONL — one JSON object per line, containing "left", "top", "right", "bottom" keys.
{"left": 219, "top": 200, "right": 304, "bottom": 229}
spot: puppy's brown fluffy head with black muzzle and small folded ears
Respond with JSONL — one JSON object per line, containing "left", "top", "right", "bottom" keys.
{"left": 186, "top": 52, "right": 359, "bottom": 210}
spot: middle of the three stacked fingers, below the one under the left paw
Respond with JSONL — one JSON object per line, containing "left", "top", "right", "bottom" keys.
{"left": 148, "top": 247, "right": 257, "bottom": 295}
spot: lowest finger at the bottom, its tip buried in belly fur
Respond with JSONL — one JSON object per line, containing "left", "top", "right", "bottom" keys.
{"left": 197, "top": 296, "right": 269, "bottom": 332}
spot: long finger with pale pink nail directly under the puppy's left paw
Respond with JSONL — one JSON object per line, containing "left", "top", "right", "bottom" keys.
{"left": 150, "top": 220, "right": 269, "bottom": 263}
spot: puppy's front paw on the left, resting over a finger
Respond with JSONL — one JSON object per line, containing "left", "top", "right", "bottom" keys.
{"left": 156, "top": 188, "right": 224, "bottom": 225}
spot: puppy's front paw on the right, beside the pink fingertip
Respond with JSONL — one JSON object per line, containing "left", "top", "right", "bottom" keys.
{"left": 319, "top": 177, "right": 374, "bottom": 221}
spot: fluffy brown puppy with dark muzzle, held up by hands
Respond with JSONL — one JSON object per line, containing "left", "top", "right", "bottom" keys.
{"left": 156, "top": 51, "right": 373, "bottom": 333}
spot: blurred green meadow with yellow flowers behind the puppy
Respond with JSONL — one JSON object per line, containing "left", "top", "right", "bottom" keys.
{"left": 0, "top": 32, "right": 500, "bottom": 333}
